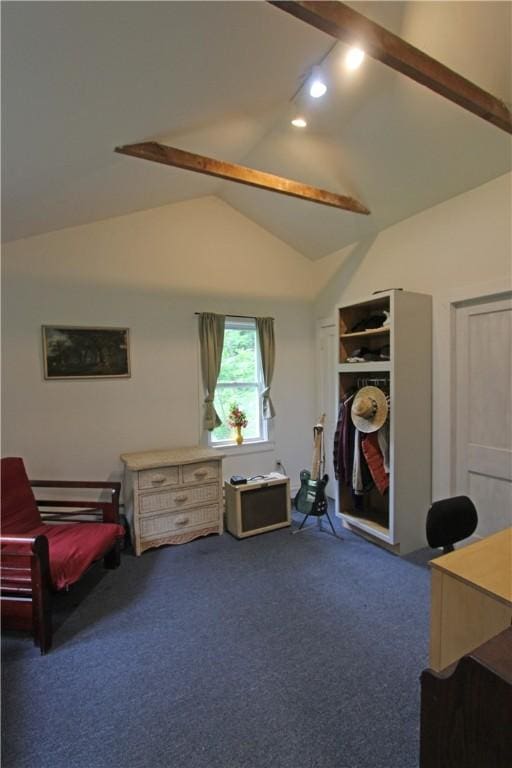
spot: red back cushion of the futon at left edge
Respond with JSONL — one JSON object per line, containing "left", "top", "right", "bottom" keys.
{"left": 0, "top": 457, "right": 41, "bottom": 534}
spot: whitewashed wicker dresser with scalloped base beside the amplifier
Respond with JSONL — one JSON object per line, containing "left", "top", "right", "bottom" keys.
{"left": 121, "top": 446, "right": 224, "bottom": 556}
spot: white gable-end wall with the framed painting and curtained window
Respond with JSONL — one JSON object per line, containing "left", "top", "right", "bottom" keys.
{"left": 2, "top": 198, "right": 314, "bottom": 488}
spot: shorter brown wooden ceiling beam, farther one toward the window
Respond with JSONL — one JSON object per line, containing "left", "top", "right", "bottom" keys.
{"left": 115, "top": 141, "right": 370, "bottom": 214}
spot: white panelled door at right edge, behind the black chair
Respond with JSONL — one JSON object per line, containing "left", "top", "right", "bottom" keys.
{"left": 453, "top": 299, "right": 512, "bottom": 536}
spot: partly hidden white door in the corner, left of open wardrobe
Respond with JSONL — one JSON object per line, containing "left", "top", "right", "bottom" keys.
{"left": 318, "top": 321, "right": 338, "bottom": 499}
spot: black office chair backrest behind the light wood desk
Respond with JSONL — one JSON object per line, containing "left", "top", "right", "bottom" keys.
{"left": 427, "top": 496, "right": 478, "bottom": 554}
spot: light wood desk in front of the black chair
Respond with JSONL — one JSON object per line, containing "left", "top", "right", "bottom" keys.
{"left": 430, "top": 528, "right": 512, "bottom": 672}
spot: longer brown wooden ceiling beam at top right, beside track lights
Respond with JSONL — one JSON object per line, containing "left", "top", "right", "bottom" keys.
{"left": 269, "top": 0, "right": 512, "bottom": 133}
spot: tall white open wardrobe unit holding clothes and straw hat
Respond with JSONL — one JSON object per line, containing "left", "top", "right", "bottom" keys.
{"left": 336, "top": 290, "right": 432, "bottom": 554}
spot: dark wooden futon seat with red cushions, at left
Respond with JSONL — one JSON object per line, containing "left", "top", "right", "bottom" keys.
{"left": 0, "top": 458, "right": 124, "bottom": 654}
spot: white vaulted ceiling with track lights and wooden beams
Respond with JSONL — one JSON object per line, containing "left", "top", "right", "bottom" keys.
{"left": 2, "top": 0, "right": 512, "bottom": 259}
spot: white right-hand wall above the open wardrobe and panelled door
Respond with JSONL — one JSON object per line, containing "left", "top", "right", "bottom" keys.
{"left": 314, "top": 174, "right": 512, "bottom": 510}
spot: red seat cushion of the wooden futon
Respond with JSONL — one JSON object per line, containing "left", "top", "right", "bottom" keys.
{"left": 23, "top": 523, "right": 124, "bottom": 589}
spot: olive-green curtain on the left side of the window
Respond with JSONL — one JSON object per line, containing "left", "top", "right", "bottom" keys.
{"left": 199, "top": 312, "right": 226, "bottom": 432}
